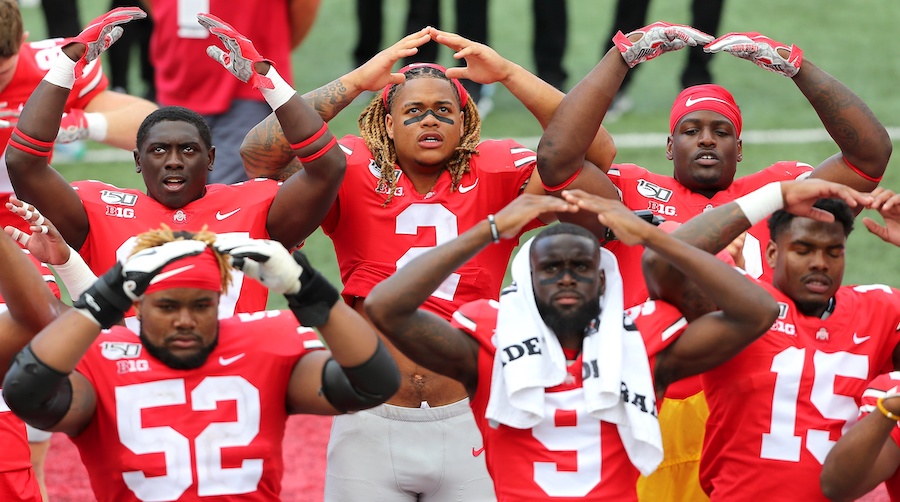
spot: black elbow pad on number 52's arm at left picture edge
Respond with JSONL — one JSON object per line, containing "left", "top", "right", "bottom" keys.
{"left": 3, "top": 345, "right": 72, "bottom": 429}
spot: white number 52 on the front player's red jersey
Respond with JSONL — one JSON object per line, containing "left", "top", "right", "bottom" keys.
{"left": 116, "top": 376, "right": 263, "bottom": 500}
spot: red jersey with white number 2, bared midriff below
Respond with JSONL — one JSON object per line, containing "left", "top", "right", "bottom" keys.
{"left": 322, "top": 136, "right": 541, "bottom": 319}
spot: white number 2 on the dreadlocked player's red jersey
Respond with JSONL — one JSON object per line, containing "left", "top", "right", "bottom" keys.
{"left": 396, "top": 204, "right": 460, "bottom": 301}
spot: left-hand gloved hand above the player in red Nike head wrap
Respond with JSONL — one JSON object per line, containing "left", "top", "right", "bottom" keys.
{"left": 613, "top": 21, "right": 713, "bottom": 68}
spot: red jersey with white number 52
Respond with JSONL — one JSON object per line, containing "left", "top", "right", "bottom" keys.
{"left": 73, "top": 311, "right": 323, "bottom": 502}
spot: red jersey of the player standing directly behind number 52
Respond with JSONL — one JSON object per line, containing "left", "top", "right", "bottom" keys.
{"left": 72, "top": 178, "right": 281, "bottom": 318}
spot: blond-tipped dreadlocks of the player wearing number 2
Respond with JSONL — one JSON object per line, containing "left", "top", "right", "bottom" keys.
{"left": 359, "top": 66, "right": 481, "bottom": 206}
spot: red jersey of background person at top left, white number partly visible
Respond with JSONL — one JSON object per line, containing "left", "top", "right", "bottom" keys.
{"left": 150, "top": 0, "right": 293, "bottom": 114}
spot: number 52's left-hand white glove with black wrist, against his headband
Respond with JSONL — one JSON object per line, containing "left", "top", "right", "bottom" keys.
{"left": 74, "top": 240, "right": 206, "bottom": 329}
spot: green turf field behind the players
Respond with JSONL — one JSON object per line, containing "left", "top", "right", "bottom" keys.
{"left": 15, "top": 0, "right": 900, "bottom": 306}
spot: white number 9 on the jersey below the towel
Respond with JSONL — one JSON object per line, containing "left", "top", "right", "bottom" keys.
{"left": 531, "top": 389, "right": 602, "bottom": 497}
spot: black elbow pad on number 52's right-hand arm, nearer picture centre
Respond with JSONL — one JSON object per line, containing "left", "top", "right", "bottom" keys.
{"left": 321, "top": 339, "right": 400, "bottom": 413}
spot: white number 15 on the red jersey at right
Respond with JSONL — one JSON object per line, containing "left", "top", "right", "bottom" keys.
{"left": 760, "top": 347, "right": 869, "bottom": 464}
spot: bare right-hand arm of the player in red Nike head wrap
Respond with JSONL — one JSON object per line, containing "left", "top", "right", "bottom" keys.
{"left": 793, "top": 60, "right": 892, "bottom": 192}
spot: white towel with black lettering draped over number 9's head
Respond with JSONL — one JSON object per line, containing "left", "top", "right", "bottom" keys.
{"left": 485, "top": 238, "right": 663, "bottom": 475}
